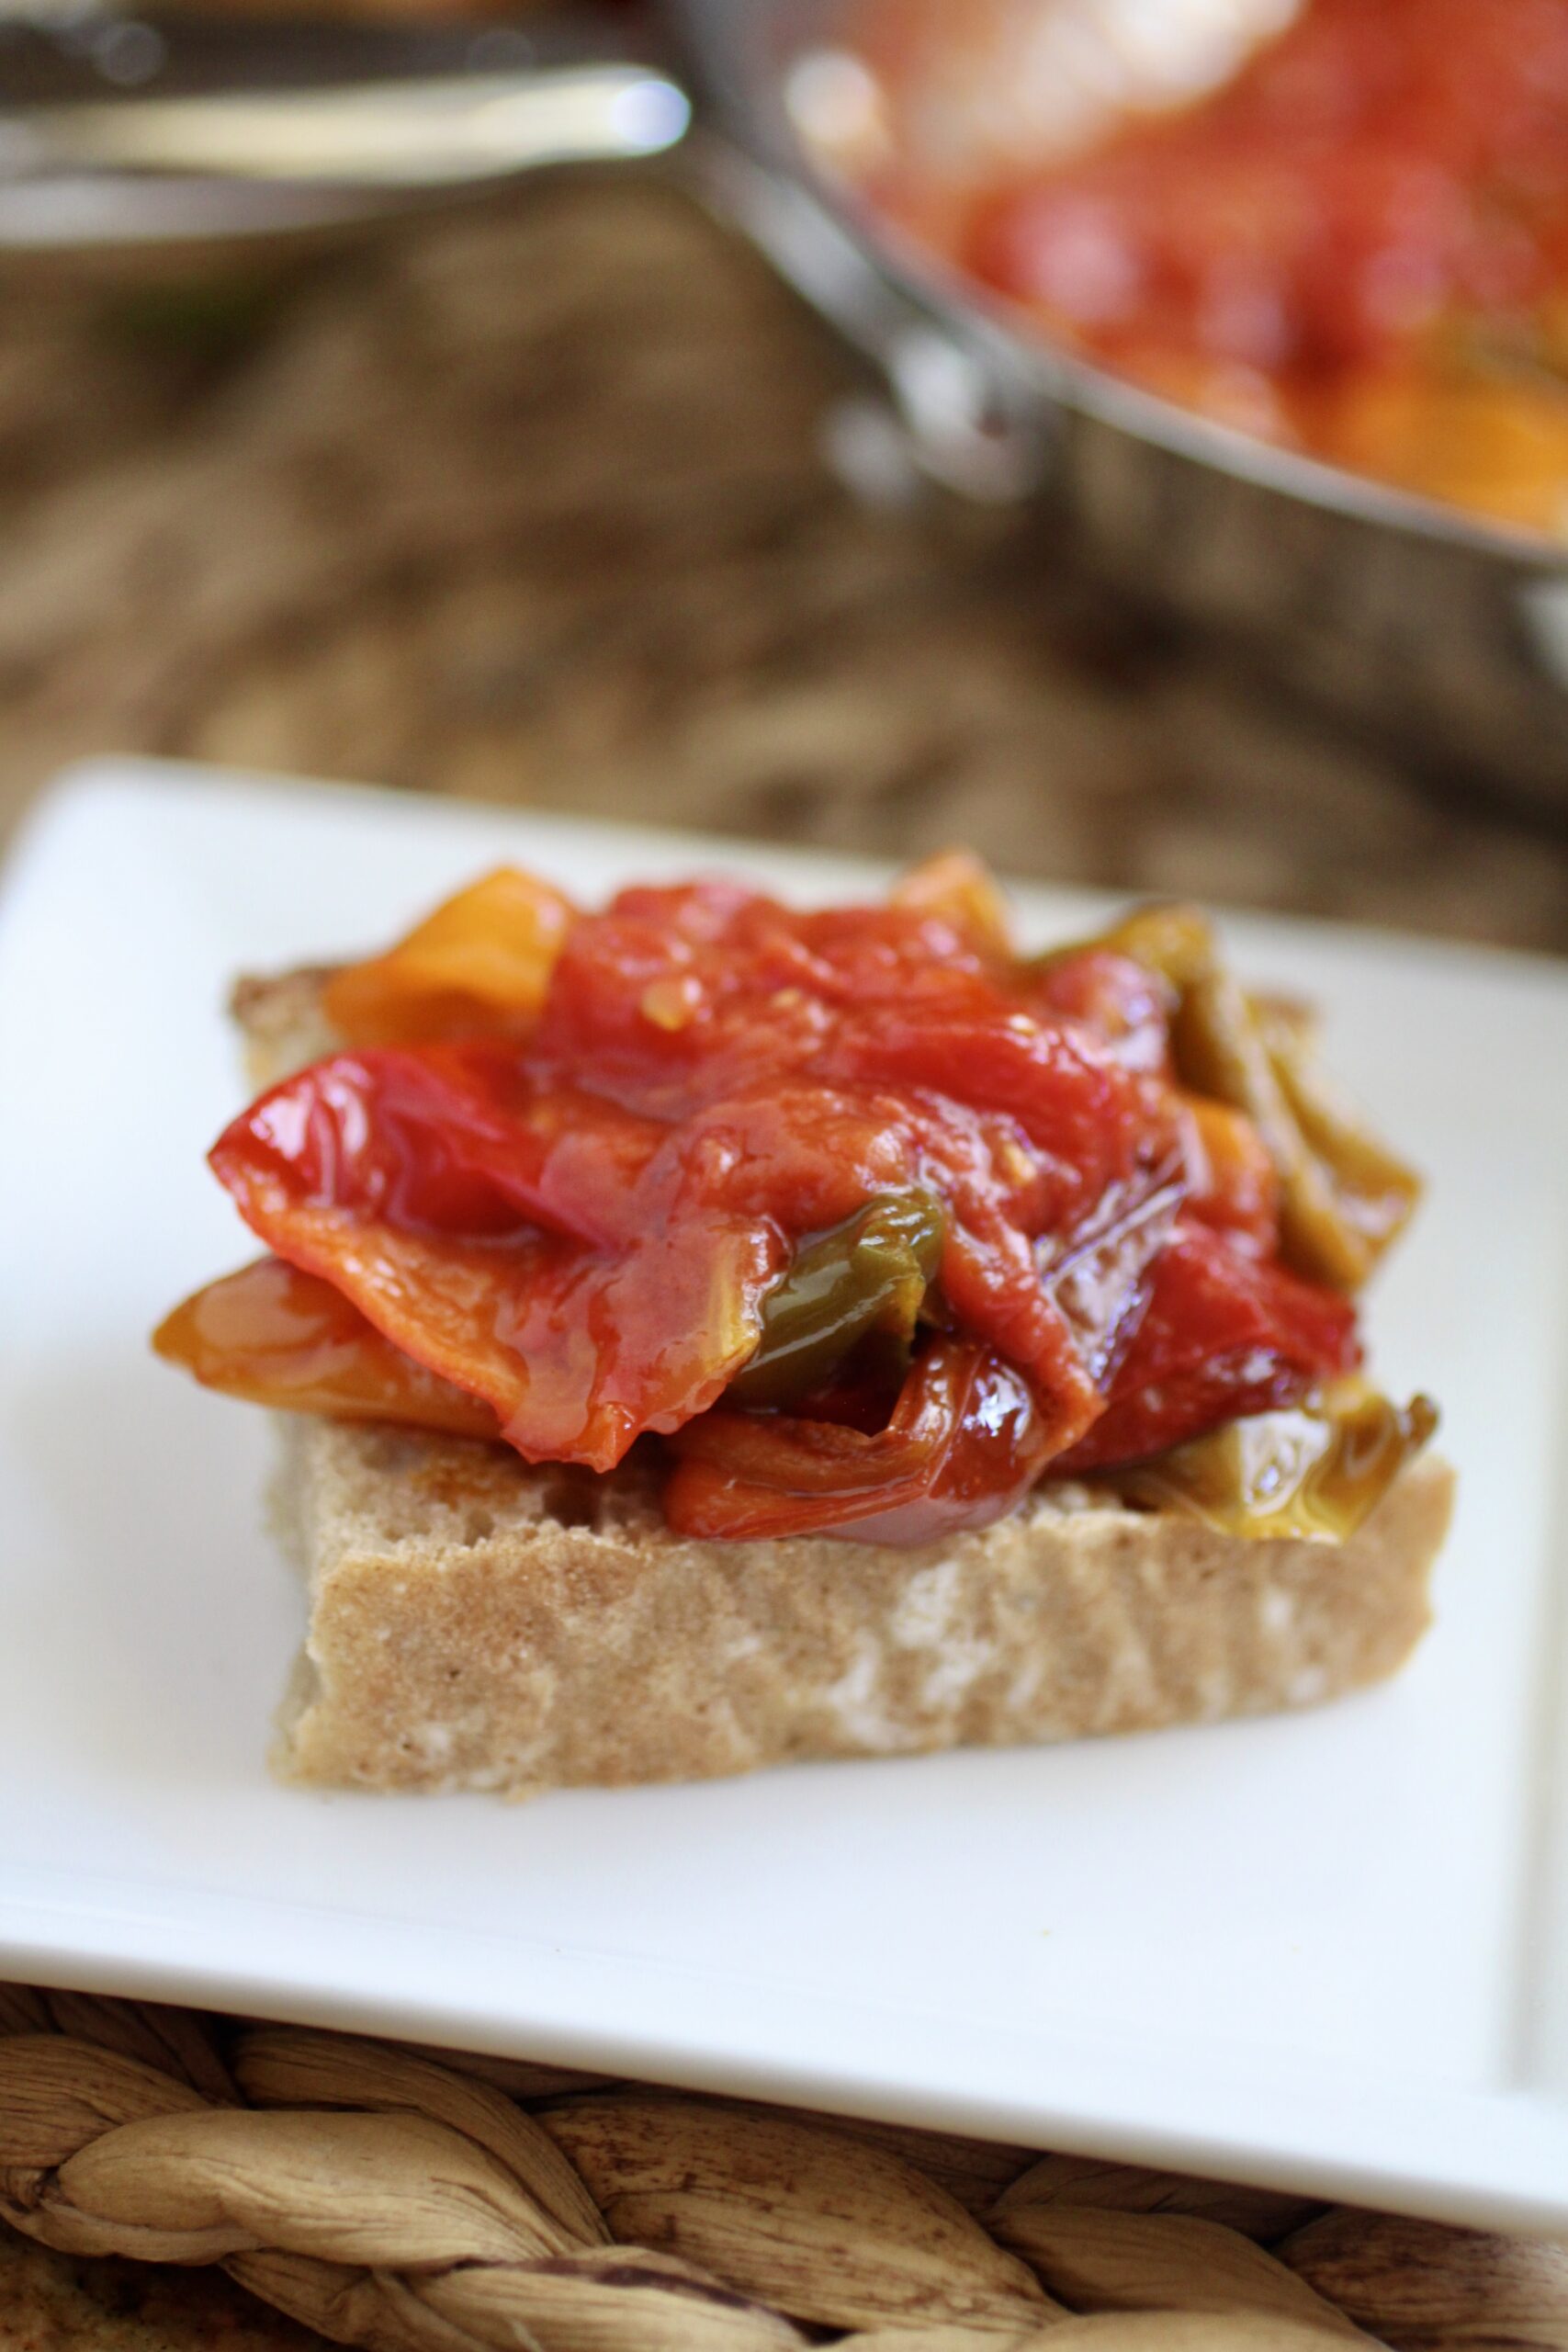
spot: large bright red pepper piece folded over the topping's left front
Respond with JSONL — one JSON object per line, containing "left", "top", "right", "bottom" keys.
{"left": 211, "top": 1049, "right": 783, "bottom": 1470}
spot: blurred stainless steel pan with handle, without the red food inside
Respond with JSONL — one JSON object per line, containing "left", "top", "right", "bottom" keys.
{"left": 0, "top": 0, "right": 1568, "bottom": 819}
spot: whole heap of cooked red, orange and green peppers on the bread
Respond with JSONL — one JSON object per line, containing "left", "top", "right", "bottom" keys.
{"left": 160, "top": 861, "right": 1438, "bottom": 1541}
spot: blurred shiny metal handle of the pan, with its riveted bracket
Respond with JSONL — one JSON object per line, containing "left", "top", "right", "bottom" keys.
{"left": 0, "top": 5, "right": 1054, "bottom": 503}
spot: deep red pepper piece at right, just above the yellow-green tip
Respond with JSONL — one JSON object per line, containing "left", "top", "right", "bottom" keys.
{"left": 1051, "top": 1218, "right": 1361, "bottom": 1477}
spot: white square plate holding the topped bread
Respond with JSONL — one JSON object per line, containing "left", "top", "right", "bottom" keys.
{"left": 0, "top": 764, "right": 1568, "bottom": 2227}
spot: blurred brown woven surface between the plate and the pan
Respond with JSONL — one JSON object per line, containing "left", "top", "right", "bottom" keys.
{"left": 0, "top": 181, "right": 1568, "bottom": 950}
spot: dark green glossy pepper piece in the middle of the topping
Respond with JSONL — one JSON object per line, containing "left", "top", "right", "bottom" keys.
{"left": 728, "top": 1190, "right": 947, "bottom": 1407}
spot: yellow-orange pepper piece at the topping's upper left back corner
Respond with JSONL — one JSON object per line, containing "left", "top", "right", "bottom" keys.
{"left": 324, "top": 865, "right": 573, "bottom": 1045}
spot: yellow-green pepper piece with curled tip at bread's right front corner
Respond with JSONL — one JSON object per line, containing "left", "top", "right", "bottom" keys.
{"left": 1110, "top": 1381, "right": 1437, "bottom": 1543}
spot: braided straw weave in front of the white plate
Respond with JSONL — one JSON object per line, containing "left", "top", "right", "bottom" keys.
{"left": 0, "top": 1985, "right": 1568, "bottom": 2352}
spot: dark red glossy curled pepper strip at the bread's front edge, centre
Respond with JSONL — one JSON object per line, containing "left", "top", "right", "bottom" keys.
{"left": 665, "top": 1339, "right": 1055, "bottom": 1543}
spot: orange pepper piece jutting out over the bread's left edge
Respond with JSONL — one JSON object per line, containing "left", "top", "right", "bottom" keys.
{"left": 152, "top": 1259, "right": 501, "bottom": 1440}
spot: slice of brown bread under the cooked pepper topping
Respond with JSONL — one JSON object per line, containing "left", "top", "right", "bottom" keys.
{"left": 235, "top": 974, "right": 1453, "bottom": 1794}
